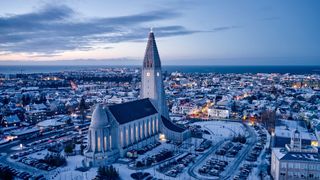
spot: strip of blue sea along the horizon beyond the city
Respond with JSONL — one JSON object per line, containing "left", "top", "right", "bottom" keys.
{"left": 0, "top": 65, "right": 320, "bottom": 74}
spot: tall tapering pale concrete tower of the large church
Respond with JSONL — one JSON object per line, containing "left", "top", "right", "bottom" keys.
{"left": 140, "top": 30, "right": 169, "bottom": 119}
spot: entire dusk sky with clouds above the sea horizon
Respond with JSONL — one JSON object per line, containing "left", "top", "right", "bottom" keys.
{"left": 0, "top": 0, "right": 320, "bottom": 65}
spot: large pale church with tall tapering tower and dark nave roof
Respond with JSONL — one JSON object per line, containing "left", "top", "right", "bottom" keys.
{"left": 85, "top": 32, "right": 190, "bottom": 166}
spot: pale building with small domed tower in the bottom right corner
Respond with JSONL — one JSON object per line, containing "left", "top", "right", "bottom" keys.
{"left": 271, "top": 130, "right": 320, "bottom": 180}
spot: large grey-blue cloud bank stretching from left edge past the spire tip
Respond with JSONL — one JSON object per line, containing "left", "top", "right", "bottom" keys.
{"left": 0, "top": 5, "right": 195, "bottom": 56}
